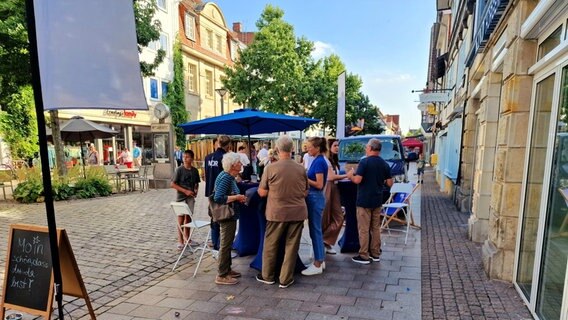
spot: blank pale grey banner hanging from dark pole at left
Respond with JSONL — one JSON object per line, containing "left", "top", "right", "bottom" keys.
{"left": 34, "top": 0, "right": 148, "bottom": 110}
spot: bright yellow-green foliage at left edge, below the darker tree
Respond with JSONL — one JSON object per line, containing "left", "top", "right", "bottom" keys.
{"left": 0, "top": 85, "right": 39, "bottom": 159}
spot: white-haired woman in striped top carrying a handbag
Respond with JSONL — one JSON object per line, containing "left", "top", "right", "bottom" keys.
{"left": 212, "top": 152, "right": 246, "bottom": 285}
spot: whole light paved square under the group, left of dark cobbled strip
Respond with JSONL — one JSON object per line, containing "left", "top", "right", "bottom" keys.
{"left": 0, "top": 175, "right": 421, "bottom": 320}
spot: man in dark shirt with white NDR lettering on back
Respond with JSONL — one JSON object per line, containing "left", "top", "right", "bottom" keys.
{"left": 205, "top": 136, "right": 231, "bottom": 250}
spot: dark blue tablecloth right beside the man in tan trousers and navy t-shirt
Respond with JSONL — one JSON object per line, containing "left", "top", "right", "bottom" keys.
{"left": 337, "top": 181, "right": 359, "bottom": 253}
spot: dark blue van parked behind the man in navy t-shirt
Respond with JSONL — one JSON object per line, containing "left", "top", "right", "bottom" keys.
{"left": 338, "top": 134, "right": 408, "bottom": 182}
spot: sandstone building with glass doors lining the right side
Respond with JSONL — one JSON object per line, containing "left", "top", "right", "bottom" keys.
{"left": 429, "top": 0, "right": 568, "bottom": 319}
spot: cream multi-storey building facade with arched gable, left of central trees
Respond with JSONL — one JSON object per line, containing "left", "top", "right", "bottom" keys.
{"left": 178, "top": 0, "right": 244, "bottom": 120}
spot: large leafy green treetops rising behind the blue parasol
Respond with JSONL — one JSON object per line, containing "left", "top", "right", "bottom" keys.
{"left": 223, "top": 5, "right": 381, "bottom": 134}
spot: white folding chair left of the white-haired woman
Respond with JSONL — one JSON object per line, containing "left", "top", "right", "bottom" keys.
{"left": 170, "top": 202, "right": 211, "bottom": 278}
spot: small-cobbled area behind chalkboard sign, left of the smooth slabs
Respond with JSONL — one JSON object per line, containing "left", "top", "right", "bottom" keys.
{"left": 0, "top": 190, "right": 191, "bottom": 319}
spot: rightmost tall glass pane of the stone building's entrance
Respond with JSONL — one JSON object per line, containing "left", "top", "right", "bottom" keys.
{"left": 536, "top": 67, "right": 568, "bottom": 319}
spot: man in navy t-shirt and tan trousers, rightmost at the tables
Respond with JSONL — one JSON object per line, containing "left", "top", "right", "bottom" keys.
{"left": 351, "top": 139, "right": 393, "bottom": 264}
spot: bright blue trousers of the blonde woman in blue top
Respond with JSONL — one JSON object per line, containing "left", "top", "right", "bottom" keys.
{"left": 306, "top": 191, "right": 325, "bottom": 261}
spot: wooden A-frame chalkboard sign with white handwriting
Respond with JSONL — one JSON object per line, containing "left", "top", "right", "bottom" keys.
{"left": 0, "top": 224, "right": 96, "bottom": 319}
